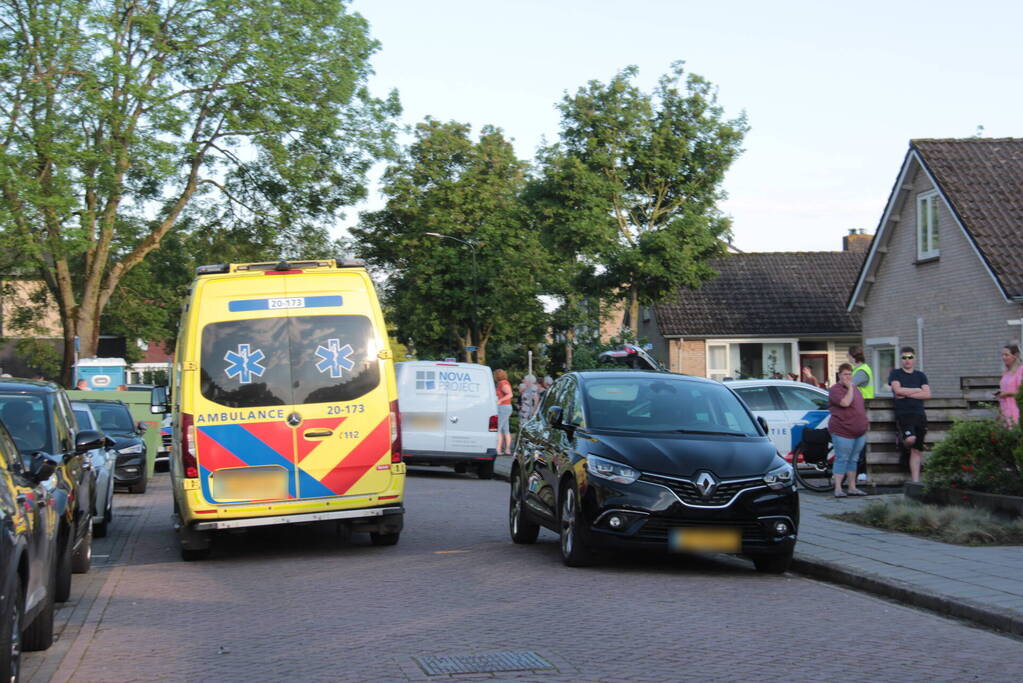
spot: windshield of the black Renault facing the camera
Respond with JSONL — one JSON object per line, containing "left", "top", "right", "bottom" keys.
{"left": 583, "top": 375, "right": 758, "bottom": 437}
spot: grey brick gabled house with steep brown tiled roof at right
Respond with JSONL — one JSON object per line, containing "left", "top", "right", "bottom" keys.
{"left": 847, "top": 138, "right": 1023, "bottom": 398}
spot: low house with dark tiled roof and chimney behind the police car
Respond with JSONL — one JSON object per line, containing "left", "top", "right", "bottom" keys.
{"left": 639, "top": 241, "right": 871, "bottom": 383}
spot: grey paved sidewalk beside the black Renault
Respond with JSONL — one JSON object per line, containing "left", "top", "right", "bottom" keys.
{"left": 494, "top": 457, "right": 1023, "bottom": 635}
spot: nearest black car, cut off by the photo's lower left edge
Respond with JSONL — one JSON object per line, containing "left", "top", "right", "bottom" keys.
{"left": 0, "top": 417, "right": 57, "bottom": 681}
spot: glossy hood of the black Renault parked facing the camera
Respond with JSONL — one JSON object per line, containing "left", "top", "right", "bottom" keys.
{"left": 579, "top": 432, "right": 777, "bottom": 479}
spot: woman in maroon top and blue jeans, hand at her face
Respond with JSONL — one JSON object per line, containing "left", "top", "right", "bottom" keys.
{"left": 828, "top": 363, "right": 870, "bottom": 498}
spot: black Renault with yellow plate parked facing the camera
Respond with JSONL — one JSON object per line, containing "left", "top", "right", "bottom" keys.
{"left": 508, "top": 370, "right": 799, "bottom": 573}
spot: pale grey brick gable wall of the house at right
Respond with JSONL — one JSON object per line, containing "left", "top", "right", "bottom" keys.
{"left": 862, "top": 165, "right": 1023, "bottom": 398}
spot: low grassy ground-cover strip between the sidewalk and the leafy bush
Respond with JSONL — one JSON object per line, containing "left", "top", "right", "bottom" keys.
{"left": 829, "top": 500, "right": 1023, "bottom": 545}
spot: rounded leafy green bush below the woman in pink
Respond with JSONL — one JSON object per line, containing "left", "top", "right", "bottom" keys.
{"left": 924, "top": 419, "right": 1023, "bottom": 496}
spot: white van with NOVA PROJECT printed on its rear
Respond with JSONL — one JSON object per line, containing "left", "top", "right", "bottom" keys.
{"left": 395, "top": 361, "right": 497, "bottom": 480}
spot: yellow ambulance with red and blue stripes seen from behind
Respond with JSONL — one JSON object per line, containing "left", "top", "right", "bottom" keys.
{"left": 153, "top": 260, "right": 405, "bottom": 559}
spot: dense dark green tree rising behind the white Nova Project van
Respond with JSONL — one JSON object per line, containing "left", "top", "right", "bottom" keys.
{"left": 352, "top": 119, "right": 546, "bottom": 364}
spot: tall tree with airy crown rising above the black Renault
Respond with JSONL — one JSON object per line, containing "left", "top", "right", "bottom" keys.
{"left": 540, "top": 62, "right": 748, "bottom": 334}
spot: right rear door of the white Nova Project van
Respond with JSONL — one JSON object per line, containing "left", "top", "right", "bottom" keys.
{"left": 438, "top": 365, "right": 497, "bottom": 456}
